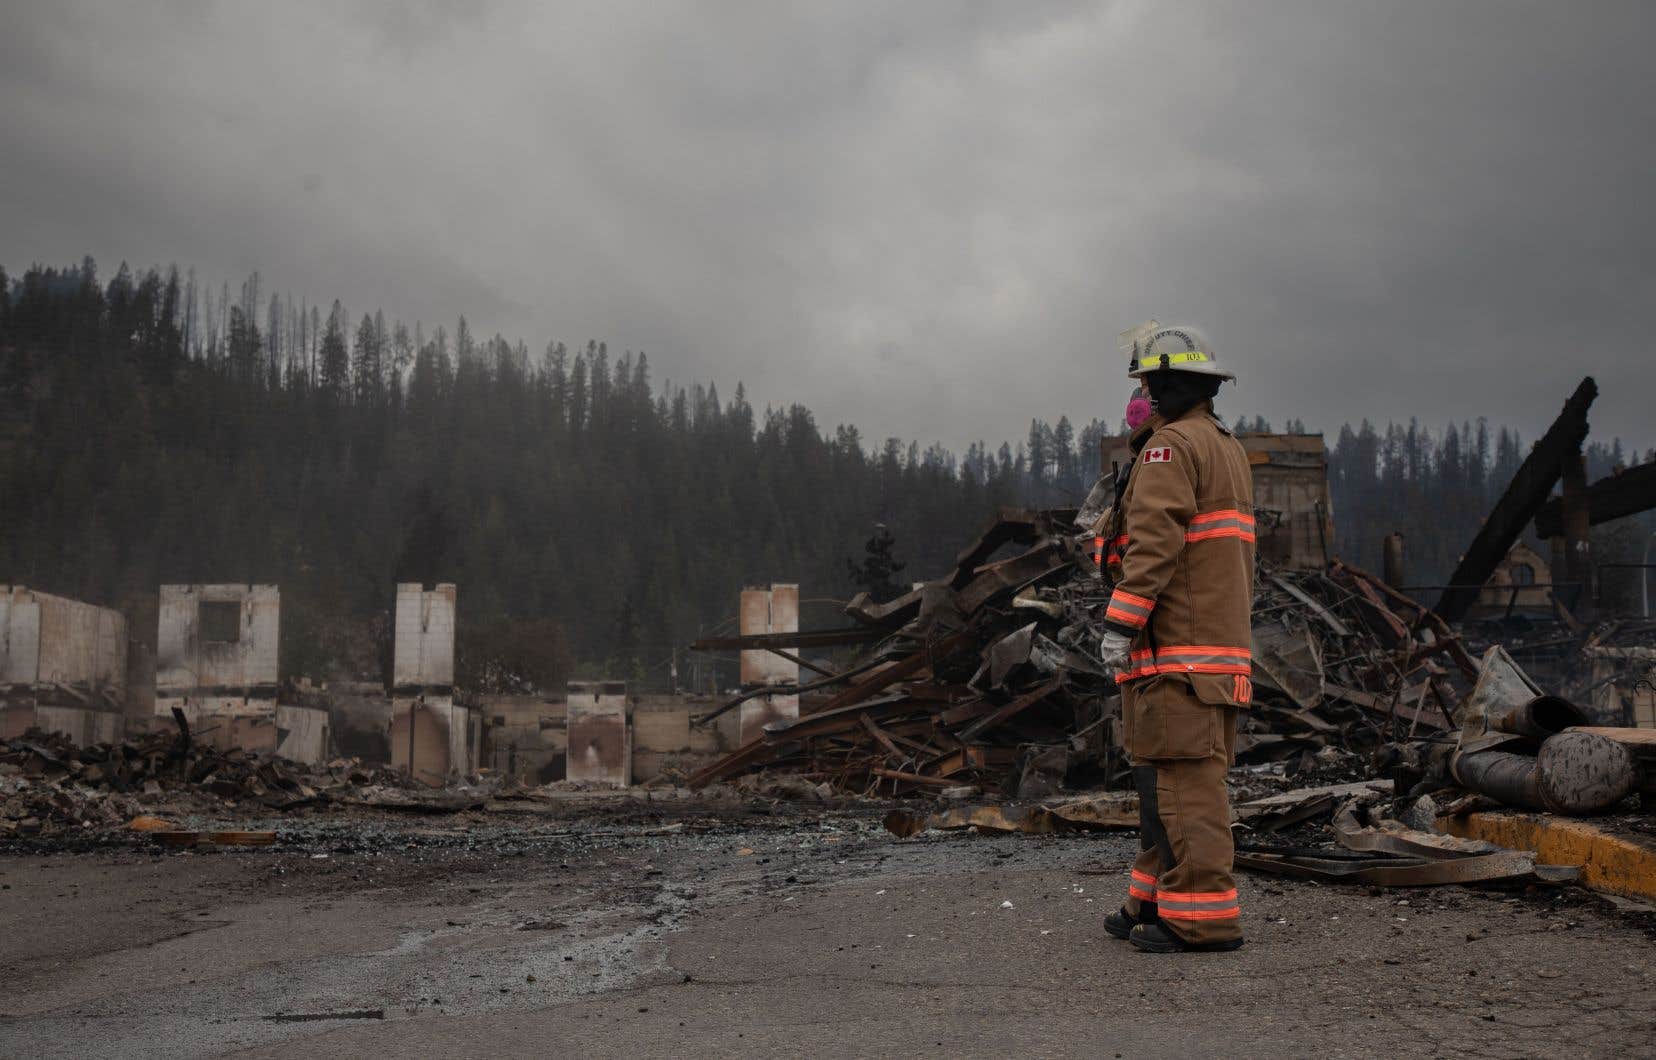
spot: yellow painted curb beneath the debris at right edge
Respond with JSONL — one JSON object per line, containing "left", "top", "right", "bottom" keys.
{"left": 1437, "top": 812, "right": 1656, "bottom": 899}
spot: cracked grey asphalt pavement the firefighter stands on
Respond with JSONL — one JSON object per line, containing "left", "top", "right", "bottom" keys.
{"left": 0, "top": 808, "right": 1656, "bottom": 1060}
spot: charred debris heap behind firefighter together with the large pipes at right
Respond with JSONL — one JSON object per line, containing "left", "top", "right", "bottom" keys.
{"left": 691, "top": 510, "right": 1651, "bottom": 830}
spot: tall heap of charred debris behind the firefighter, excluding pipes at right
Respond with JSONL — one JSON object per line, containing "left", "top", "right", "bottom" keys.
{"left": 691, "top": 510, "right": 1477, "bottom": 798}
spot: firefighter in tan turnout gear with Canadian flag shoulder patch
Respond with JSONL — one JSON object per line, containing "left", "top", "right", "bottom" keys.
{"left": 1100, "top": 321, "right": 1254, "bottom": 952}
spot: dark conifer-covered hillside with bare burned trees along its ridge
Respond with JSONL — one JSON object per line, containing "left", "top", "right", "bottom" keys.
{"left": 0, "top": 260, "right": 1631, "bottom": 686}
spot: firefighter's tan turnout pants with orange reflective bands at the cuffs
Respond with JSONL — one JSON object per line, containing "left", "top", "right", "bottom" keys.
{"left": 1121, "top": 674, "right": 1242, "bottom": 944}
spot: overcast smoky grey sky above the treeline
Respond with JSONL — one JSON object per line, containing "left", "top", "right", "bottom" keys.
{"left": 0, "top": 0, "right": 1656, "bottom": 449}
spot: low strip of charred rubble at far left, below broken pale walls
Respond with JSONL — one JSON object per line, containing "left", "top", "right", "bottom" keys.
{"left": 0, "top": 725, "right": 440, "bottom": 838}
